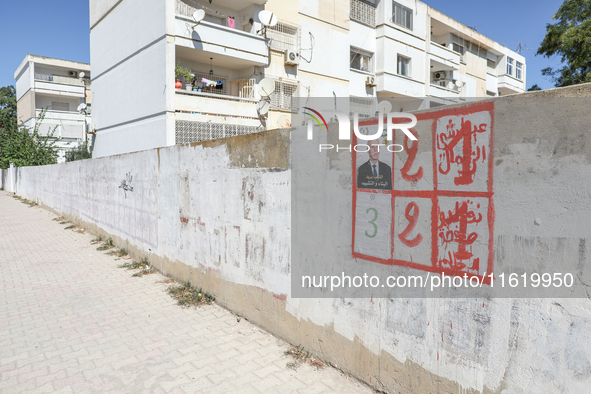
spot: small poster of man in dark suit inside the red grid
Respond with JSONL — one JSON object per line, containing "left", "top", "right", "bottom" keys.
{"left": 357, "top": 139, "right": 392, "bottom": 190}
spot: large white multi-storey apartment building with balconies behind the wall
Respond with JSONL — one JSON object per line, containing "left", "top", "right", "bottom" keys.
{"left": 89, "top": 0, "right": 526, "bottom": 157}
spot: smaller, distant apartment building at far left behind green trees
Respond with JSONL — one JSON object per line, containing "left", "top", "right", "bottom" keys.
{"left": 14, "top": 55, "right": 91, "bottom": 162}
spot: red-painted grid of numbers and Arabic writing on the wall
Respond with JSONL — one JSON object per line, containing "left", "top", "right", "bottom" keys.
{"left": 352, "top": 102, "right": 494, "bottom": 283}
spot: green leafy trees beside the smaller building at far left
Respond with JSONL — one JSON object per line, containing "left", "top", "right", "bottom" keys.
{"left": 0, "top": 86, "right": 58, "bottom": 168}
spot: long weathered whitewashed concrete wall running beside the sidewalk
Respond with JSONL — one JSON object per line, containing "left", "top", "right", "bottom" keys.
{"left": 11, "top": 85, "right": 591, "bottom": 394}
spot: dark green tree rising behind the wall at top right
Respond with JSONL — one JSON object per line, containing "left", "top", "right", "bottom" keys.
{"left": 536, "top": 0, "right": 591, "bottom": 87}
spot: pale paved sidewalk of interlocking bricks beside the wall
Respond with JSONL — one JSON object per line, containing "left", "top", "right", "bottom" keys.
{"left": 0, "top": 191, "right": 372, "bottom": 394}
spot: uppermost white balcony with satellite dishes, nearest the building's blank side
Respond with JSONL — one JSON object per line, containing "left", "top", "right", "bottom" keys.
{"left": 175, "top": 0, "right": 269, "bottom": 69}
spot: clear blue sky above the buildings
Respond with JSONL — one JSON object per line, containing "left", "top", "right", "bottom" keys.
{"left": 0, "top": 0, "right": 562, "bottom": 89}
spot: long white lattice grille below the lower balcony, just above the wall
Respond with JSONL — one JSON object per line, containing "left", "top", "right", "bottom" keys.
{"left": 175, "top": 120, "right": 264, "bottom": 145}
